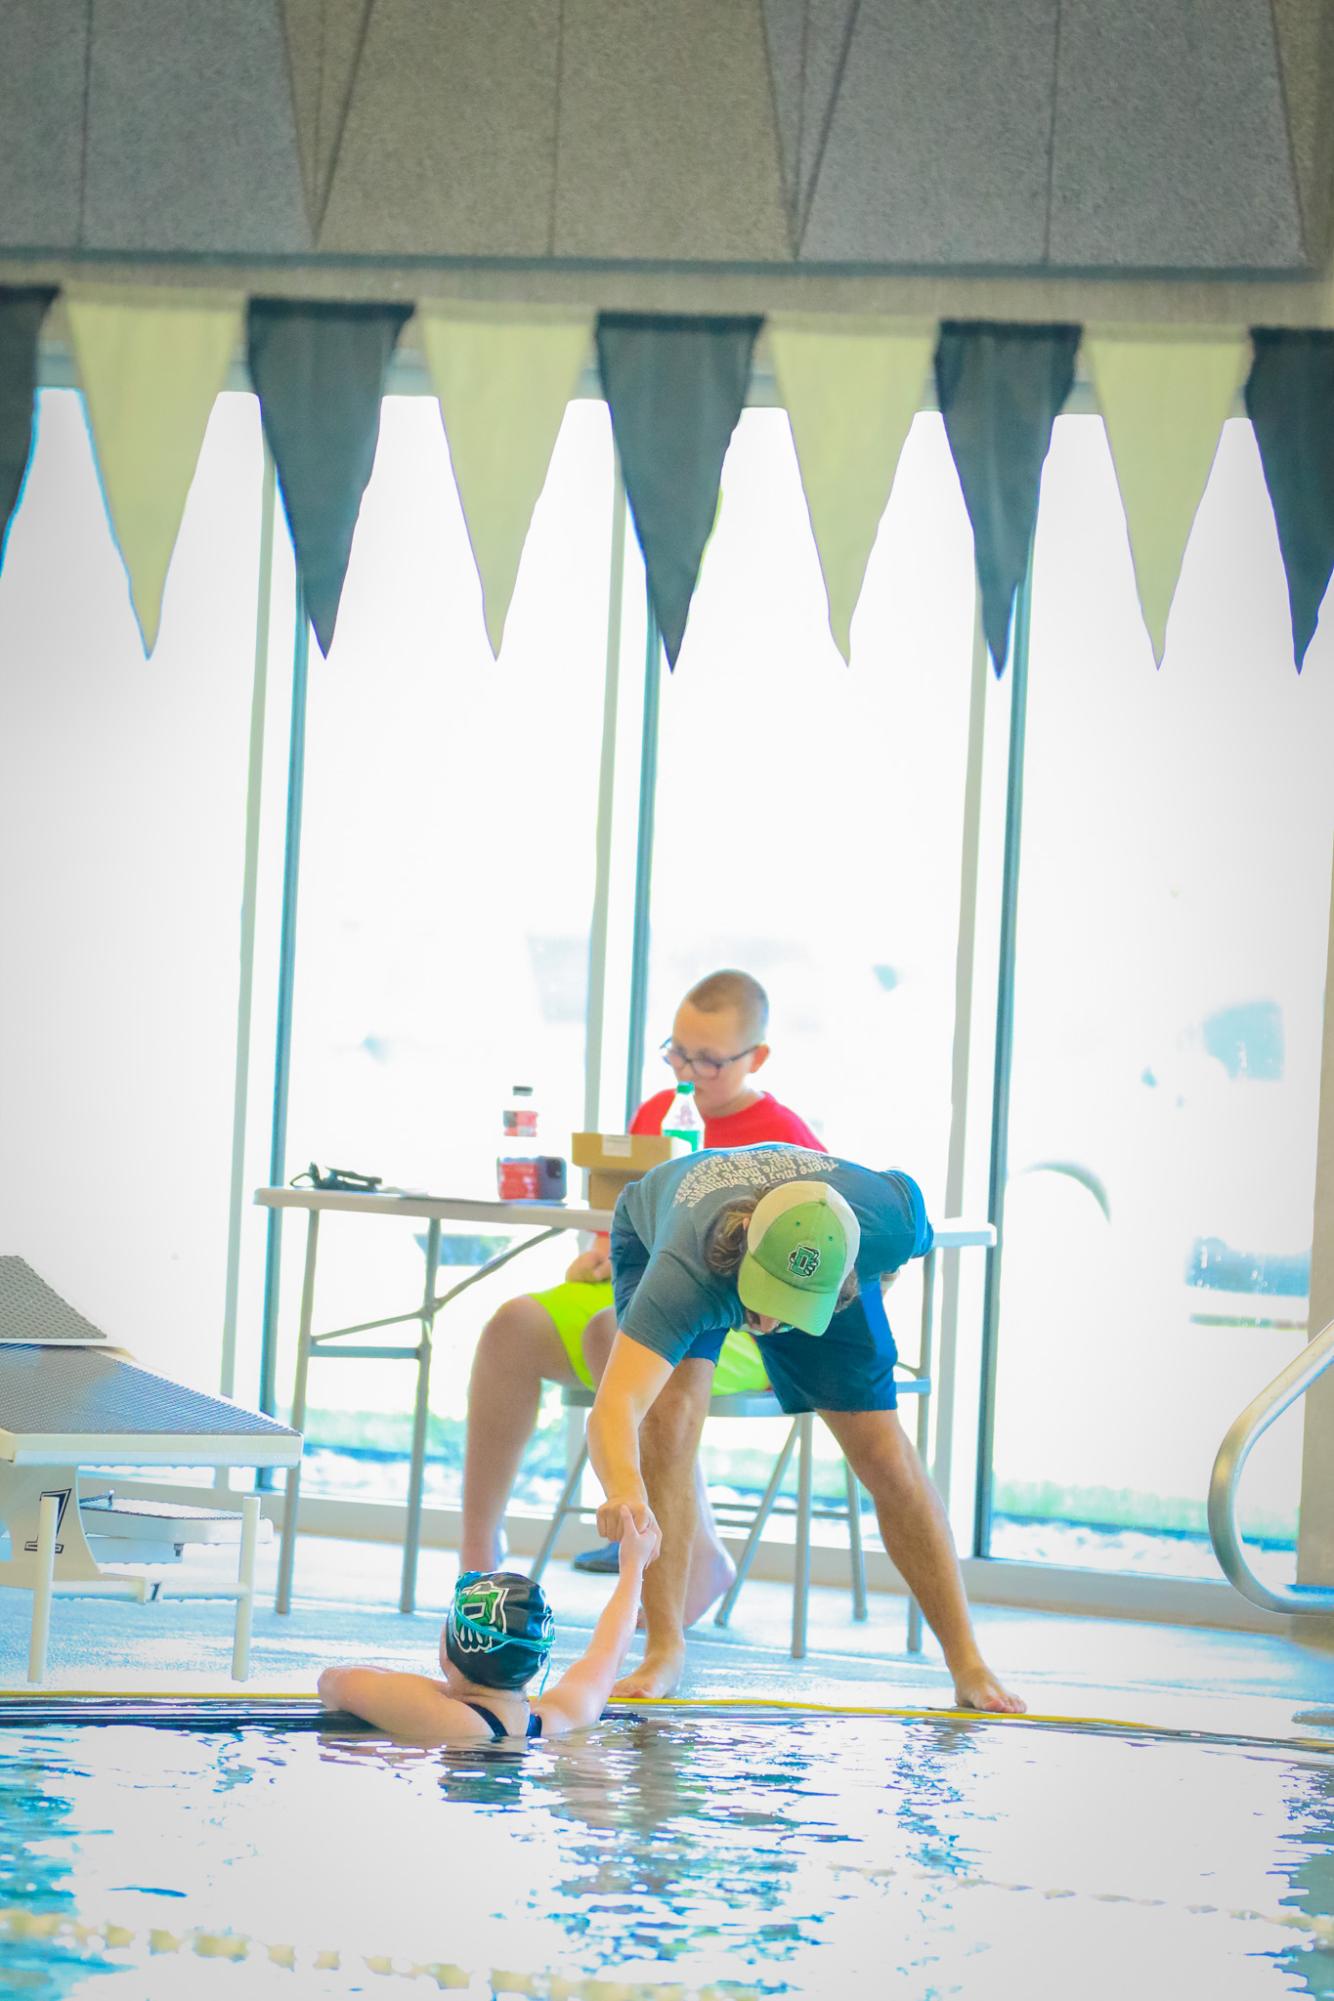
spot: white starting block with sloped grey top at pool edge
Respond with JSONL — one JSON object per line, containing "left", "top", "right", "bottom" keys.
{"left": 0, "top": 1257, "right": 302, "bottom": 1681}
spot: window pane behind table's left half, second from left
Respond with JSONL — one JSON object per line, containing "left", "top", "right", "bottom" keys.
{"left": 278, "top": 396, "right": 612, "bottom": 1493}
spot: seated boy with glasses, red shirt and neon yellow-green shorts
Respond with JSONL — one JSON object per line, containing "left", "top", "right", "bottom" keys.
{"left": 460, "top": 968, "right": 822, "bottom": 1625}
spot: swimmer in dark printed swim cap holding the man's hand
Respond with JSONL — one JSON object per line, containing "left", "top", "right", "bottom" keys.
{"left": 320, "top": 1509, "right": 658, "bottom": 1745}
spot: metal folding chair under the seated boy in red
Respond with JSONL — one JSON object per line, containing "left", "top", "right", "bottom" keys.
{"left": 532, "top": 1365, "right": 932, "bottom": 1661}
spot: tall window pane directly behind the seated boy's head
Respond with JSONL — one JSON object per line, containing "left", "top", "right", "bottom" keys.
{"left": 644, "top": 408, "right": 974, "bottom": 1512}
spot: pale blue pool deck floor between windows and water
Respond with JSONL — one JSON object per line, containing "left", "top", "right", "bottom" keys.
{"left": 0, "top": 1537, "right": 1334, "bottom": 1749}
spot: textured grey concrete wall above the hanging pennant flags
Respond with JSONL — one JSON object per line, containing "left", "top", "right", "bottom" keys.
{"left": 0, "top": 0, "right": 1334, "bottom": 274}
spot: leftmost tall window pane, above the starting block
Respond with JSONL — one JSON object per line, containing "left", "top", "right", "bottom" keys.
{"left": 0, "top": 388, "right": 262, "bottom": 1391}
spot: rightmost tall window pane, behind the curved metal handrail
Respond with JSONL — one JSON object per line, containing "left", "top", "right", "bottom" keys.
{"left": 992, "top": 416, "right": 1334, "bottom": 1579}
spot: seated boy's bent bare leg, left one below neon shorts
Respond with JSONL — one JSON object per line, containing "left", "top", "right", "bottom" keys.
{"left": 458, "top": 1297, "right": 578, "bottom": 1571}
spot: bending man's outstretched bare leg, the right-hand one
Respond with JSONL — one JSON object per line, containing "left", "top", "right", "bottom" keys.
{"left": 820, "top": 1411, "right": 1026, "bottom": 1715}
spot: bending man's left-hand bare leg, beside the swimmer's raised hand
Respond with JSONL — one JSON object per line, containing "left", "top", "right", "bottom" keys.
{"left": 612, "top": 1361, "right": 714, "bottom": 1699}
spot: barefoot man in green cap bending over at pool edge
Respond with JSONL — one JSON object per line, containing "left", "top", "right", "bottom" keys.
{"left": 588, "top": 1145, "right": 1024, "bottom": 1715}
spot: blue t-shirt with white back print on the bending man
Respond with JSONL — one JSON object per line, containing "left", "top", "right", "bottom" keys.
{"left": 612, "top": 1145, "right": 932, "bottom": 1365}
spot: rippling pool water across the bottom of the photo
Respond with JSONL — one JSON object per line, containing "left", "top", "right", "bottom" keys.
{"left": 0, "top": 1711, "right": 1334, "bottom": 2001}
